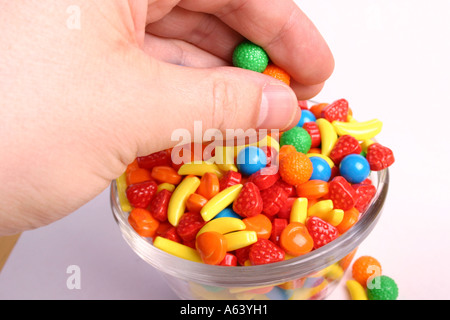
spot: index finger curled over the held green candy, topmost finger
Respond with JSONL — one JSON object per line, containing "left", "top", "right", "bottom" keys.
{"left": 178, "top": 0, "right": 334, "bottom": 85}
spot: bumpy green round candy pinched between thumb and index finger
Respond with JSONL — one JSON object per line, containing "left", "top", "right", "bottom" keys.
{"left": 233, "top": 41, "right": 269, "bottom": 72}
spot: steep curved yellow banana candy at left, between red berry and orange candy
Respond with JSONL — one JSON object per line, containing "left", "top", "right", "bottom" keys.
{"left": 167, "top": 176, "right": 200, "bottom": 227}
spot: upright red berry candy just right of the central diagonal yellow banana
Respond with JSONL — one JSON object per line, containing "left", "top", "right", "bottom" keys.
{"left": 233, "top": 182, "right": 263, "bottom": 218}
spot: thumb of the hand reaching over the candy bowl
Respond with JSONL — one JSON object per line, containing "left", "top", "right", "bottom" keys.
{"left": 111, "top": 56, "right": 300, "bottom": 156}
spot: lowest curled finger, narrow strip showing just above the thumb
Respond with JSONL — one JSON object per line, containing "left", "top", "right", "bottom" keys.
{"left": 143, "top": 34, "right": 228, "bottom": 68}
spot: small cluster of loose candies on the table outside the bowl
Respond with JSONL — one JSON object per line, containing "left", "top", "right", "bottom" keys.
{"left": 347, "top": 256, "right": 398, "bottom": 300}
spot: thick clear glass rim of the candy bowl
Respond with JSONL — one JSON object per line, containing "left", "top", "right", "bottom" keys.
{"left": 110, "top": 168, "right": 389, "bottom": 287}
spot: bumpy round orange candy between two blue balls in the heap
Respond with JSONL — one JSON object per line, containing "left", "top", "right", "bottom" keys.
{"left": 279, "top": 152, "right": 313, "bottom": 186}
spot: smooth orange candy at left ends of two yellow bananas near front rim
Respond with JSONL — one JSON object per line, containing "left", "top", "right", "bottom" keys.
{"left": 195, "top": 231, "right": 227, "bottom": 265}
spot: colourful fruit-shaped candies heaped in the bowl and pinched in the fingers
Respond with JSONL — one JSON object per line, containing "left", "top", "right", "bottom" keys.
{"left": 117, "top": 42, "right": 394, "bottom": 266}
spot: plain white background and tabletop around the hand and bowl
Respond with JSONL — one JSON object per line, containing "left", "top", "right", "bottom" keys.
{"left": 0, "top": 0, "right": 450, "bottom": 299}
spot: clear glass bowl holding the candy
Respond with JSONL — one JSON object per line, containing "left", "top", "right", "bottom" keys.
{"left": 111, "top": 169, "right": 389, "bottom": 300}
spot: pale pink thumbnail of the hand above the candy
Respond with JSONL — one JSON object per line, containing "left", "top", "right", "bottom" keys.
{"left": 257, "top": 84, "right": 299, "bottom": 130}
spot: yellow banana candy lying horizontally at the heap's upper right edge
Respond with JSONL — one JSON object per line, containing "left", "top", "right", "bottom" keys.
{"left": 332, "top": 119, "right": 383, "bottom": 140}
